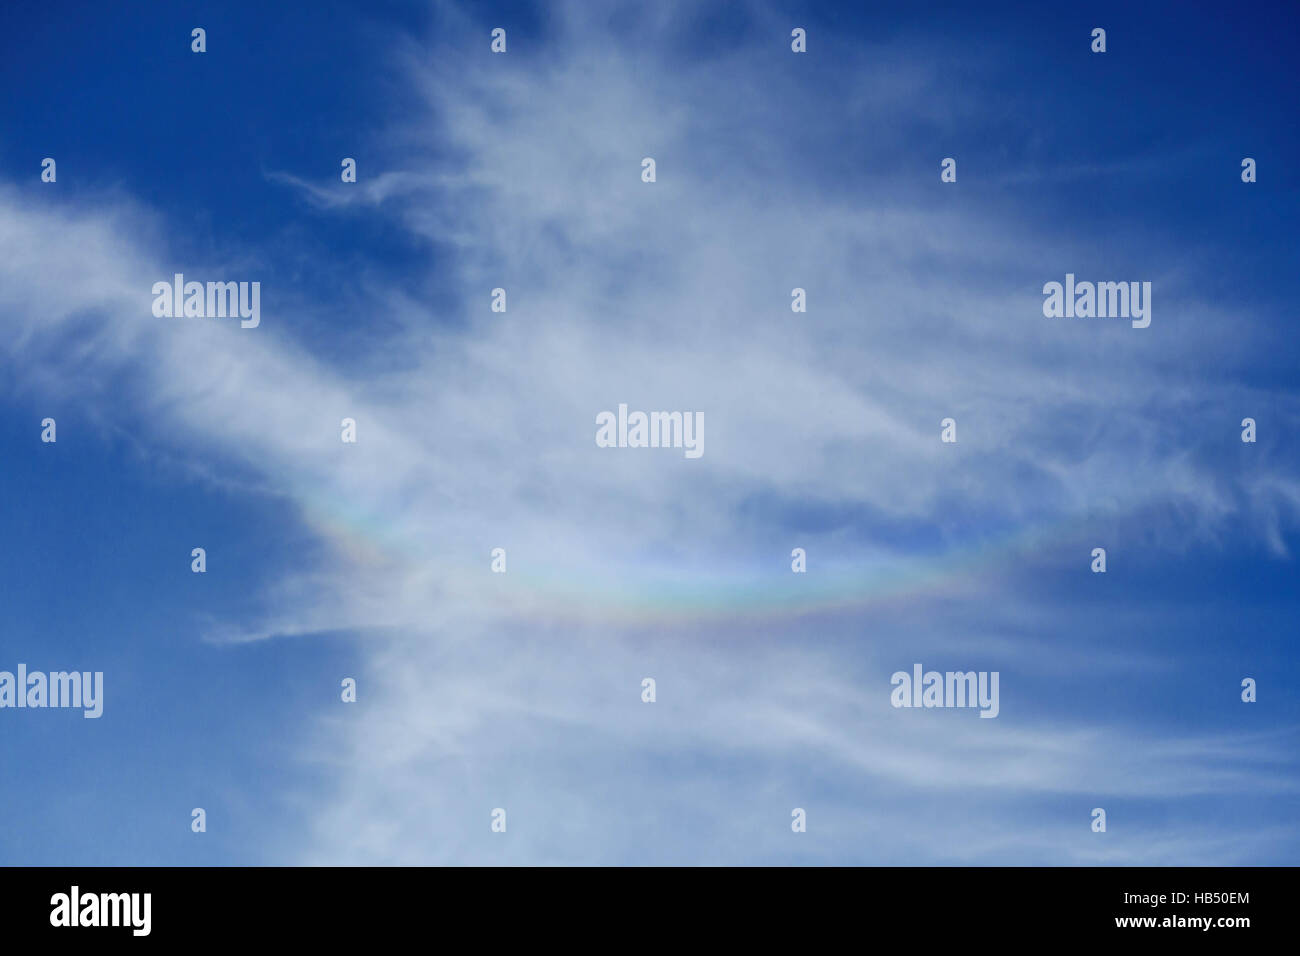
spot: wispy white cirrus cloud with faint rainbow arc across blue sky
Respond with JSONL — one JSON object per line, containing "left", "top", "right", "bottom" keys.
{"left": 0, "top": 5, "right": 1300, "bottom": 862}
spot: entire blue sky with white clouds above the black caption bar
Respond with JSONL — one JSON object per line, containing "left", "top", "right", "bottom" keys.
{"left": 0, "top": 3, "right": 1300, "bottom": 865}
